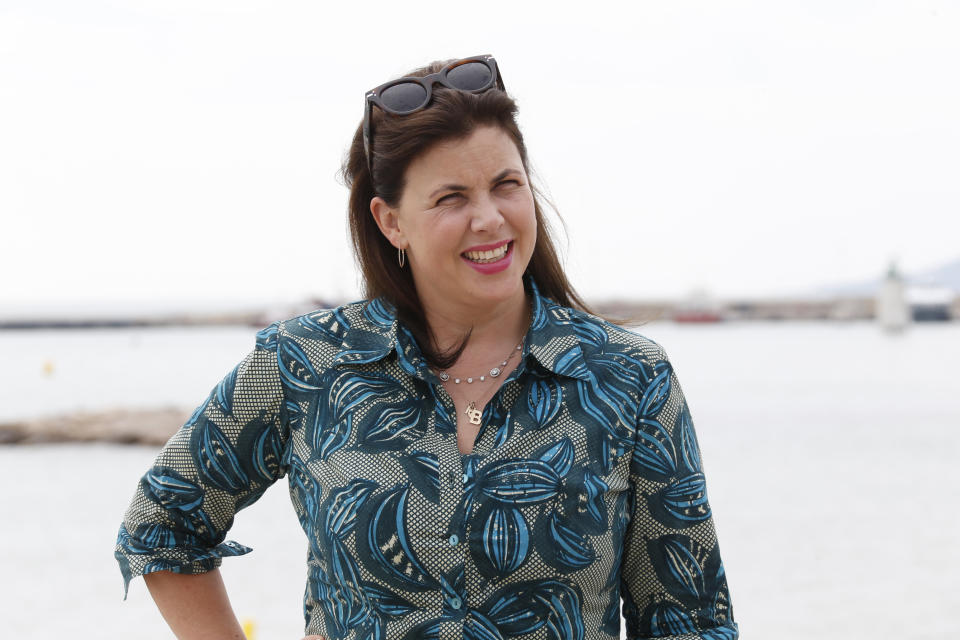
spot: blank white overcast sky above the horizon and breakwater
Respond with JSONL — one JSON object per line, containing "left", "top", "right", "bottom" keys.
{"left": 0, "top": 0, "right": 960, "bottom": 308}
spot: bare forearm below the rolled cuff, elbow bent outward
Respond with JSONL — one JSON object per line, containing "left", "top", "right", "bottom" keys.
{"left": 143, "top": 569, "right": 245, "bottom": 640}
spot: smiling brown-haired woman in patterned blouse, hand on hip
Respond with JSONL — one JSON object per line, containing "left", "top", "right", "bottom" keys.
{"left": 116, "top": 56, "right": 738, "bottom": 640}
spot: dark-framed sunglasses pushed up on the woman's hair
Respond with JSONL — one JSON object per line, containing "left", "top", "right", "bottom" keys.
{"left": 363, "top": 56, "right": 505, "bottom": 173}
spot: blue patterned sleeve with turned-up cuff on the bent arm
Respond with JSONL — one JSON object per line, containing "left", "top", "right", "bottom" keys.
{"left": 114, "top": 323, "right": 288, "bottom": 598}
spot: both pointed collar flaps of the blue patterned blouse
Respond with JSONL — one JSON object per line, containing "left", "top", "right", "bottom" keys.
{"left": 332, "top": 276, "right": 590, "bottom": 380}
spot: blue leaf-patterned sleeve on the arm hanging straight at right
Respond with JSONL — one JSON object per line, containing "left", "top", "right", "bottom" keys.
{"left": 621, "top": 345, "right": 739, "bottom": 640}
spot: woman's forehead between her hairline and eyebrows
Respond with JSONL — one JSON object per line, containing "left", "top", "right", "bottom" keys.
{"left": 406, "top": 127, "right": 523, "bottom": 189}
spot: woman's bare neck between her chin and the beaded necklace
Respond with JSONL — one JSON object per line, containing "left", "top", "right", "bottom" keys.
{"left": 424, "top": 286, "right": 530, "bottom": 360}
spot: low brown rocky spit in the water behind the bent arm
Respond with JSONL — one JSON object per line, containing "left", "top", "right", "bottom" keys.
{"left": 0, "top": 407, "right": 192, "bottom": 445}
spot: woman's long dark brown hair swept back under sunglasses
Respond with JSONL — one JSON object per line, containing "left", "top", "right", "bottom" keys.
{"left": 342, "top": 61, "right": 589, "bottom": 369}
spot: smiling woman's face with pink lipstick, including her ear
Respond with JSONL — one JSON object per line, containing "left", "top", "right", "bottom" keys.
{"left": 370, "top": 126, "right": 537, "bottom": 320}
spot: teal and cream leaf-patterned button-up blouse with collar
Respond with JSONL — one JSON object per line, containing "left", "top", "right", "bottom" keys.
{"left": 115, "top": 279, "right": 738, "bottom": 640}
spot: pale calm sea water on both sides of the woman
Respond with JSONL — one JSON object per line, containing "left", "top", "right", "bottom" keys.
{"left": 0, "top": 322, "right": 960, "bottom": 640}
